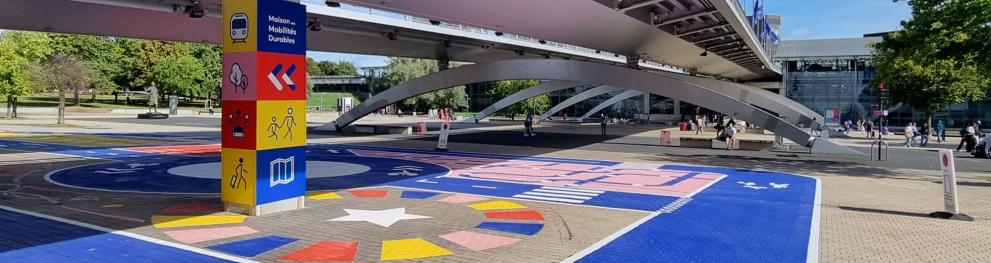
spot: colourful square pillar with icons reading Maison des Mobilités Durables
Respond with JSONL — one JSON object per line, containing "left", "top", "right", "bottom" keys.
{"left": 220, "top": 0, "right": 306, "bottom": 215}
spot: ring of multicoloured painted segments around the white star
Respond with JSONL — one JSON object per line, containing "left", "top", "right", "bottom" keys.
{"left": 151, "top": 188, "right": 544, "bottom": 262}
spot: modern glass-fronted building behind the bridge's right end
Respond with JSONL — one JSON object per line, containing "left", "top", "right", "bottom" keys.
{"left": 774, "top": 34, "right": 991, "bottom": 127}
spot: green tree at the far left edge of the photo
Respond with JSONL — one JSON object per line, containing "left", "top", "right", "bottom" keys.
{"left": 0, "top": 31, "right": 52, "bottom": 118}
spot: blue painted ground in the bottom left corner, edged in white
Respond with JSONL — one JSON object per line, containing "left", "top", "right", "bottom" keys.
{"left": 0, "top": 209, "right": 229, "bottom": 263}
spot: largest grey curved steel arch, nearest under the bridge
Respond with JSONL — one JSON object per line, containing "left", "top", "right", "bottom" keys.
{"left": 321, "top": 59, "right": 862, "bottom": 154}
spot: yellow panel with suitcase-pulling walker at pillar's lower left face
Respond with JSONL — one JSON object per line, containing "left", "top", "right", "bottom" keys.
{"left": 220, "top": 148, "right": 258, "bottom": 205}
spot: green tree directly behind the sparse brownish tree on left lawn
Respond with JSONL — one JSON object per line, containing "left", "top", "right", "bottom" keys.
{"left": 51, "top": 34, "right": 127, "bottom": 106}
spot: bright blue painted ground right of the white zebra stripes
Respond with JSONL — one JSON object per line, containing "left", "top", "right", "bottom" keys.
{"left": 579, "top": 165, "right": 818, "bottom": 263}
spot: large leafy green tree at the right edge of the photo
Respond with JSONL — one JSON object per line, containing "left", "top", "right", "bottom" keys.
{"left": 872, "top": 0, "right": 991, "bottom": 134}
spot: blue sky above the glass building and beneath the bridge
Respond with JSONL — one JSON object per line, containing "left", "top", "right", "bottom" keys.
{"left": 306, "top": 0, "right": 912, "bottom": 67}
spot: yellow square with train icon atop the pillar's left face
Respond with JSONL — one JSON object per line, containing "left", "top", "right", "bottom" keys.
{"left": 220, "top": 0, "right": 262, "bottom": 52}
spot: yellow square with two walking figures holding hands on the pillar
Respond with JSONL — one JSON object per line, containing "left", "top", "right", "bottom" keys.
{"left": 255, "top": 100, "right": 306, "bottom": 150}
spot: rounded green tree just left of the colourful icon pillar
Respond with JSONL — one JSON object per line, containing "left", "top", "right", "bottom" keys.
{"left": 152, "top": 55, "right": 206, "bottom": 99}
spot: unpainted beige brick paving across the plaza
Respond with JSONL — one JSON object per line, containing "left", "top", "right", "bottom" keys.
{"left": 0, "top": 116, "right": 991, "bottom": 262}
